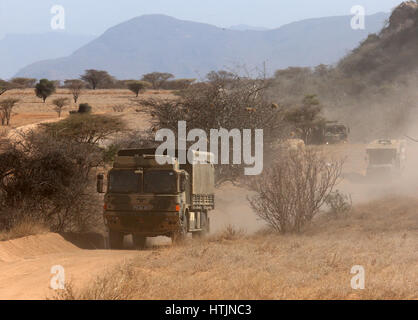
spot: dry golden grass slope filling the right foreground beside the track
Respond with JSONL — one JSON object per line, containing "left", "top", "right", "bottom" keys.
{"left": 61, "top": 198, "right": 418, "bottom": 299}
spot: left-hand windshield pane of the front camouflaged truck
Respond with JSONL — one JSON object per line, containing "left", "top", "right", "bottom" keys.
{"left": 109, "top": 170, "right": 141, "bottom": 193}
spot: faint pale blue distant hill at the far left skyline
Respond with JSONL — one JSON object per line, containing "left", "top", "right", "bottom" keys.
{"left": 0, "top": 32, "right": 94, "bottom": 79}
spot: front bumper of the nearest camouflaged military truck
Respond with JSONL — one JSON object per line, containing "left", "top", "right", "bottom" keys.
{"left": 103, "top": 211, "right": 180, "bottom": 237}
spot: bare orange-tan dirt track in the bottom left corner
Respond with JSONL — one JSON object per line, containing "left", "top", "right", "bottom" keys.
{"left": 0, "top": 233, "right": 138, "bottom": 299}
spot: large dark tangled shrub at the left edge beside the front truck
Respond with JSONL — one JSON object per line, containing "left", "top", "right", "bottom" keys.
{"left": 0, "top": 130, "right": 102, "bottom": 232}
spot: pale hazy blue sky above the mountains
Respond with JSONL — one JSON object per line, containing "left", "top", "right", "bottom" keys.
{"left": 0, "top": 0, "right": 402, "bottom": 37}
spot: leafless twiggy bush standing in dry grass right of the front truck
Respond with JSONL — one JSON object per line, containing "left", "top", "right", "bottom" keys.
{"left": 248, "top": 149, "right": 342, "bottom": 233}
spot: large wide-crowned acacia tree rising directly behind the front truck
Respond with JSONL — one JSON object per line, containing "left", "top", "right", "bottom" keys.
{"left": 138, "top": 71, "right": 285, "bottom": 185}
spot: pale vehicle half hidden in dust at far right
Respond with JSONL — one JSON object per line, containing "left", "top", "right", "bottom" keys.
{"left": 366, "top": 139, "right": 406, "bottom": 178}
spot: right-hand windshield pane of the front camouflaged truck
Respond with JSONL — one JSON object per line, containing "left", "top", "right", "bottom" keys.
{"left": 144, "top": 171, "right": 177, "bottom": 194}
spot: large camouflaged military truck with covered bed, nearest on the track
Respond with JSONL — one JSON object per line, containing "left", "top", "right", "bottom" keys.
{"left": 97, "top": 149, "right": 215, "bottom": 249}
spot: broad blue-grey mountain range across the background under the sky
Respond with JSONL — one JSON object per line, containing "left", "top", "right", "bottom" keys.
{"left": 16, "top": 13, "right": 389, "bottom": 80}
